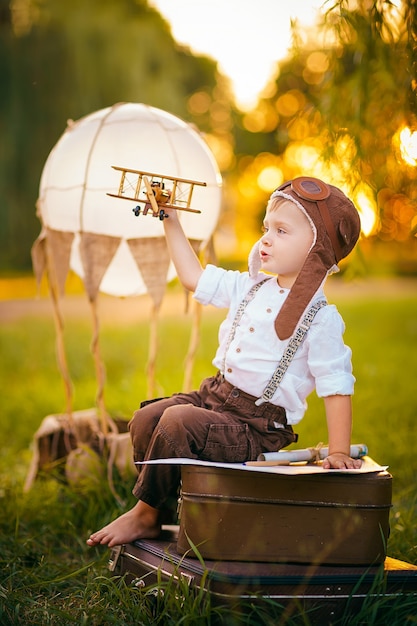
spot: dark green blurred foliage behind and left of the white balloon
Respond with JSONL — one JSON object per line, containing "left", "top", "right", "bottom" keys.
{"left": 0, "top": 0, "right": 223, "bottom": 269}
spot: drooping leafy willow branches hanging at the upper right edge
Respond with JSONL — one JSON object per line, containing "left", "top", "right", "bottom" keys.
{"left": 318, "top": 0, "right": 417, "bottom": 248}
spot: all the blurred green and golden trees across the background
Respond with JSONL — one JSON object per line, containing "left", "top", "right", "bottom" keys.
{"left": 0, "top": 0, "right": 417, "bottom": 274}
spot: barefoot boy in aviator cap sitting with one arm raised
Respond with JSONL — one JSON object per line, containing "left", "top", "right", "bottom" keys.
{"left": 87, "top": 177, "right": 361, "bottom": 547}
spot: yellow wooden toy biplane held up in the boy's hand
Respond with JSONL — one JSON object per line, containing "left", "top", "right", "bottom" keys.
{"left": 107, "top": 165, "right": 206, "bottom": 220}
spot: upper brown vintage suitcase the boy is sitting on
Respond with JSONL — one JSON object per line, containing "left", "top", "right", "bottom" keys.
{"left": 177, "top": 465, "right": 392, "bottom": 565}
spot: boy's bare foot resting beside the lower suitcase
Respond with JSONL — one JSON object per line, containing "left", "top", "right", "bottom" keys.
{"left": 87, "top": 500, "right": 161, "bottom": 548}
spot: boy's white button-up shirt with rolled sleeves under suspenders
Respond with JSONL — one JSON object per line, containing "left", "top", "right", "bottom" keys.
{"left": 194, "top": 265, "right": 355, "bottom": 424}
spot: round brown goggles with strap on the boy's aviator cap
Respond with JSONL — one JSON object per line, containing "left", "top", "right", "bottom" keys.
{"left": 275, "top": 176, "right": 343, "bottom": 260}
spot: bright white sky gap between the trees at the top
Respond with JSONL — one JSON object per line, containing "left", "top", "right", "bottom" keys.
{"left": 148, "top": 0, "right": 324, "bottom": 110}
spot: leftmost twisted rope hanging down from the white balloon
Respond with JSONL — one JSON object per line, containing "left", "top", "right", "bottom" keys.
{"left": 46, "top": 240, "right": 73, "bottom": 425}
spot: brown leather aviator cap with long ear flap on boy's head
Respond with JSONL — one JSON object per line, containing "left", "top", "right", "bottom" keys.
{"left": 255, "top": 177, "right": 361, "bottom": 339}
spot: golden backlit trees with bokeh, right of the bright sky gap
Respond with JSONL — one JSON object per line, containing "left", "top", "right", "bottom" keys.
{"left": 231, "top": 0, "right": 417, "bottom": 267}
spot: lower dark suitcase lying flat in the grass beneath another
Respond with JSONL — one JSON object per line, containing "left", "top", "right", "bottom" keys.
{"left": 109, "top": 527, "right": 417, "bottom": 626}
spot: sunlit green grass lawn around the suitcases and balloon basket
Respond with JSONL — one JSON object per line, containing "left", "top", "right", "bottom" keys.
{"left": 0, "top": 286, "right": 417, "bottom": 626}
